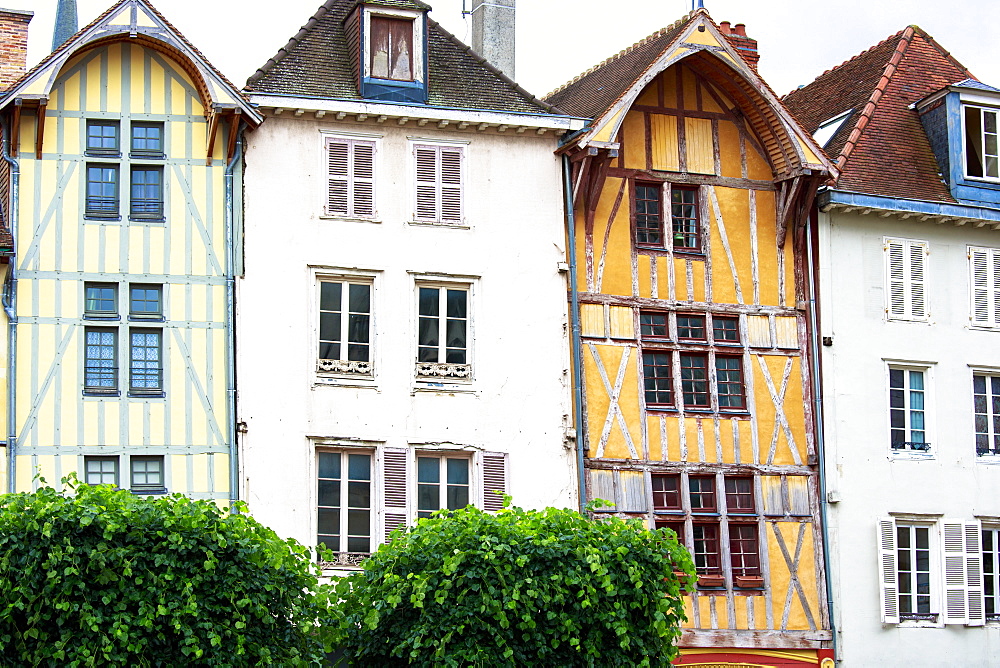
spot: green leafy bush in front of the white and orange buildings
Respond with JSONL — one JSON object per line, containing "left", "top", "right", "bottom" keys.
{"left": 336, "top": 499, "right": 694, "bottom": 666}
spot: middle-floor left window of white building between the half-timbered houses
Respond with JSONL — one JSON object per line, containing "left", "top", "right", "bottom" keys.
{"left": 317, "top": 279, "right": 372, "bottom": 374}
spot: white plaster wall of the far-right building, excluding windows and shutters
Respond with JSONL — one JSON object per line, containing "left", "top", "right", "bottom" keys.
{"left": 819, "top": 212, "right": 1000, "bottom": 668}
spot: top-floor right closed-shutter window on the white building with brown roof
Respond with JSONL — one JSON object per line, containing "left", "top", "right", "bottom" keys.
{"left": 413, "top": 144, "right": 463, "bottom": 224}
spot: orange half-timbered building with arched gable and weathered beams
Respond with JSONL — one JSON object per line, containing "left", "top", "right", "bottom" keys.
{"left": 547, "top": 9, "right": 836, "bottom": 666}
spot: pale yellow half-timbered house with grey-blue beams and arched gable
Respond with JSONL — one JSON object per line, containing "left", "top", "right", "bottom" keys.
{"left": 0, "top": 0, "right": 260, "bottom": 499}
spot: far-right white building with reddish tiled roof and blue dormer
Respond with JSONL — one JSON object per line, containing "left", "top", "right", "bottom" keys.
{"left": 785, "top": 27, "right": 1000, "bottom": 666}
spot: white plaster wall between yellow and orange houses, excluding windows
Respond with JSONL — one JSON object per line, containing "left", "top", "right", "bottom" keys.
{"left": 237, "top": 114, "right": 577, "bottom": 545}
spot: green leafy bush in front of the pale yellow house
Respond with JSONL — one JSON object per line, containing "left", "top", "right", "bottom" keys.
{"left": 0, "top": 480, "right": 329, "bottom": 666}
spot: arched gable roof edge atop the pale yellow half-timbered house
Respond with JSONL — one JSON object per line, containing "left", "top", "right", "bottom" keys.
{"left": 0, "top": 0, "right": 263, "bottom": 126}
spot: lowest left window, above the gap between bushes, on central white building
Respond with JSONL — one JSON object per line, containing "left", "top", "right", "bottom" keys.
{"left": 316, "top": 452, "right": 373, "bottom": 553}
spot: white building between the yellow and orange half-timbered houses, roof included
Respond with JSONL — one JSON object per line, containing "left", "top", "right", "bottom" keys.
{"left": 238, "top": 0, "right": 582, "bottom": 566}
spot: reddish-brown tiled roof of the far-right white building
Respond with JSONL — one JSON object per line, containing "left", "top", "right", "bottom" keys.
{"left": 783, "top": 26, "right": 972, "bottom": 202}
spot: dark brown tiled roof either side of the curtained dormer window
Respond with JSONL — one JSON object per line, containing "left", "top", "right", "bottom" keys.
{"left": 246, "top": 0, "right": 561, "bottom": 114}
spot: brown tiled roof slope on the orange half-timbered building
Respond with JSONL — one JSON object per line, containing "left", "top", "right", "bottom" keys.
{"left": 545, "top": 14, "right": 692, "bottom": 118}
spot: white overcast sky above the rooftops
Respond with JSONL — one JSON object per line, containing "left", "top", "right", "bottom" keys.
{"left": 2, "top": 0, "right": 1000, "bottom": 102}
